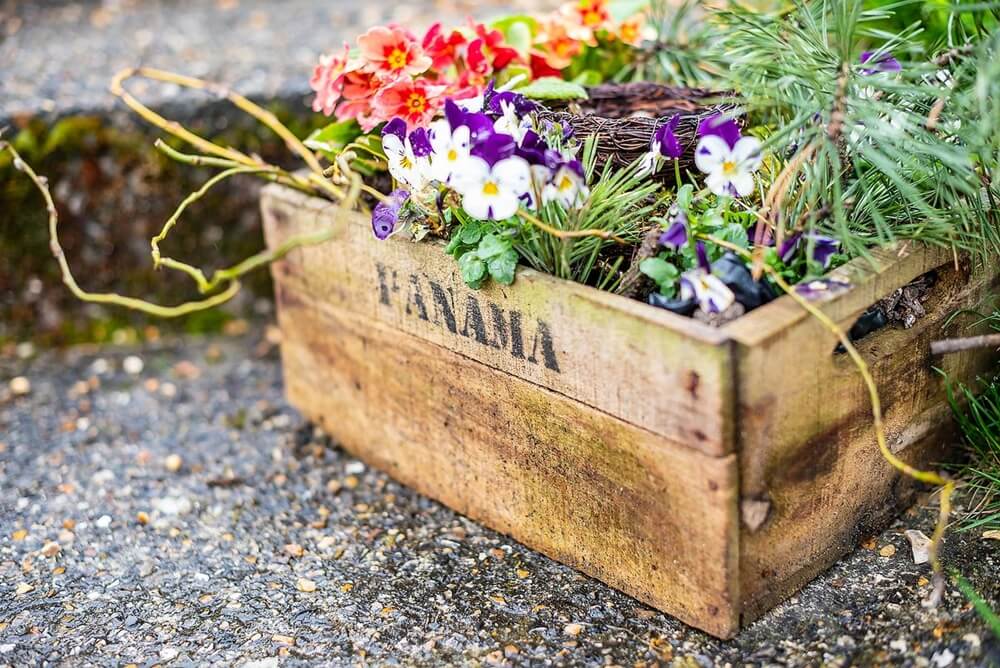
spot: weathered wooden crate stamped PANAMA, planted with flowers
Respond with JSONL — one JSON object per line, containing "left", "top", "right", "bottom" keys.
{"left": 263, "top": 186, "right": 996, "bottom": 637}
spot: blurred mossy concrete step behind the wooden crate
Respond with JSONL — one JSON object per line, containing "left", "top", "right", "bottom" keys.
{"left": 0, "top": 0, "right": 551, "bottom": 341}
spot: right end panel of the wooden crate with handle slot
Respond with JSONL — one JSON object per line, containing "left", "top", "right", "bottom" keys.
{"left": 727, "top": 248, "right": 995, "bottom": 620}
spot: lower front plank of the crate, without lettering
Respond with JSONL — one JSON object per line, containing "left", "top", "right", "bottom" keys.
{"left": 276, "top": 280, "right": 739, "bottom": 637}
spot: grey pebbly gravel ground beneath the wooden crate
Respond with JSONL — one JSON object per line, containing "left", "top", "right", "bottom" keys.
{"left": 0, "top": 330, "right": 1000, "bottom": 667}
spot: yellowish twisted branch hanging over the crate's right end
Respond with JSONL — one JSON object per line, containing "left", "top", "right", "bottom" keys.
{"left": 699, "top": 234, "right": 955, "bottom": 603}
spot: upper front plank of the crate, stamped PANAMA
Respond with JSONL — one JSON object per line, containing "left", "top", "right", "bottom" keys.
{"left": 264, "top": 187, "right": 734, "bottom": 455}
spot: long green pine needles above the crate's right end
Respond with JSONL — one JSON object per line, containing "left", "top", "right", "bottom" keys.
{"left": 718, "top": 0, "right": 1000, "bottom": 262}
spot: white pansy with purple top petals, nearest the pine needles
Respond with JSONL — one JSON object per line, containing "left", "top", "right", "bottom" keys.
{"left": 694, "top": 114, "right": 761, "bottom": 197}
